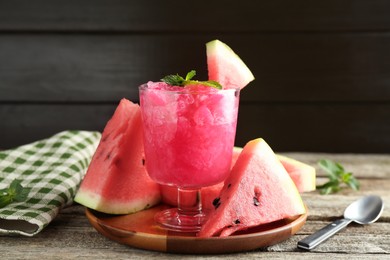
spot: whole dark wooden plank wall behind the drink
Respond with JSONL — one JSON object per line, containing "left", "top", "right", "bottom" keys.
{"left": 0, "top": 0, "right": 390, "bottom": 153}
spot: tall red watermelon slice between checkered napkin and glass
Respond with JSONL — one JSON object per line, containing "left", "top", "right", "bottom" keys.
{"left": 74, "top": 99, "right": 161, "bottom": 214}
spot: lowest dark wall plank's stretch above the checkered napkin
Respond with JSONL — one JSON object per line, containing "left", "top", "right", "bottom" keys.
{"left": 0, "top": 104, "right": 117, "bottom": 149}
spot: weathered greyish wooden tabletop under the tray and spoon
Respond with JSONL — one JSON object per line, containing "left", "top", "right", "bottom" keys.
{"left": 0, "top": 153, "right": 390, "bottom": 259}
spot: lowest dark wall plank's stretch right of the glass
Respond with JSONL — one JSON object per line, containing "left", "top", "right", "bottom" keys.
{"left": 236, "top": 103, "right": 390, "bottom": 153}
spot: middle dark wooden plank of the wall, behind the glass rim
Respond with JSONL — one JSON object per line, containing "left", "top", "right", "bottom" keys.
{"left": 0, "top": 34, "right": 390, "bottom": 102}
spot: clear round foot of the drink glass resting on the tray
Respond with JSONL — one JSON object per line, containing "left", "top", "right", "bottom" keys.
{"left": 154, "top": 208, "right": 205, "bottom": 232}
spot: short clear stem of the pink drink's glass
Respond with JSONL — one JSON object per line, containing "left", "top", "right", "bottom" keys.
{"left": 177, "top": 188, "right": 203, "bottom": 216}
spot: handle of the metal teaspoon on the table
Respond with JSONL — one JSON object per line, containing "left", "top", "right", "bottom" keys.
{"left": 298, "top": 218, "right": 352, "bottom": 250}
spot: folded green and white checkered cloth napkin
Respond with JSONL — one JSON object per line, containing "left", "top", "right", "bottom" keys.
{"left": 0, "top": 131, "right": 101, "bottom": 236}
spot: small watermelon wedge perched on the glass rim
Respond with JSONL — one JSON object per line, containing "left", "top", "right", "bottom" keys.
{"left": 206, "top": 40, "right": 255, "bottom": 89}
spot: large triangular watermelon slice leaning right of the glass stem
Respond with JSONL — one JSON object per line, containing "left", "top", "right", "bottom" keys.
{"left": 198, "top": 138, "right": 306, "bottom": 237}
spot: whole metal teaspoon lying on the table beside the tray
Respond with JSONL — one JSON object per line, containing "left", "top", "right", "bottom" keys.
{"left": 298, "top": 195, "right": 384, "bottom": 250}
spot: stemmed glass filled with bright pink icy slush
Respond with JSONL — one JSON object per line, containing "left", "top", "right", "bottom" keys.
{"left": 139, "top": 82, "right": 240, "bottom": 232}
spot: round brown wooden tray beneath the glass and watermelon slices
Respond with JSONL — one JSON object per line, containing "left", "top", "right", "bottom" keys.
{"left": 86, "top": 205, "right": 307, "bottom": 254}
